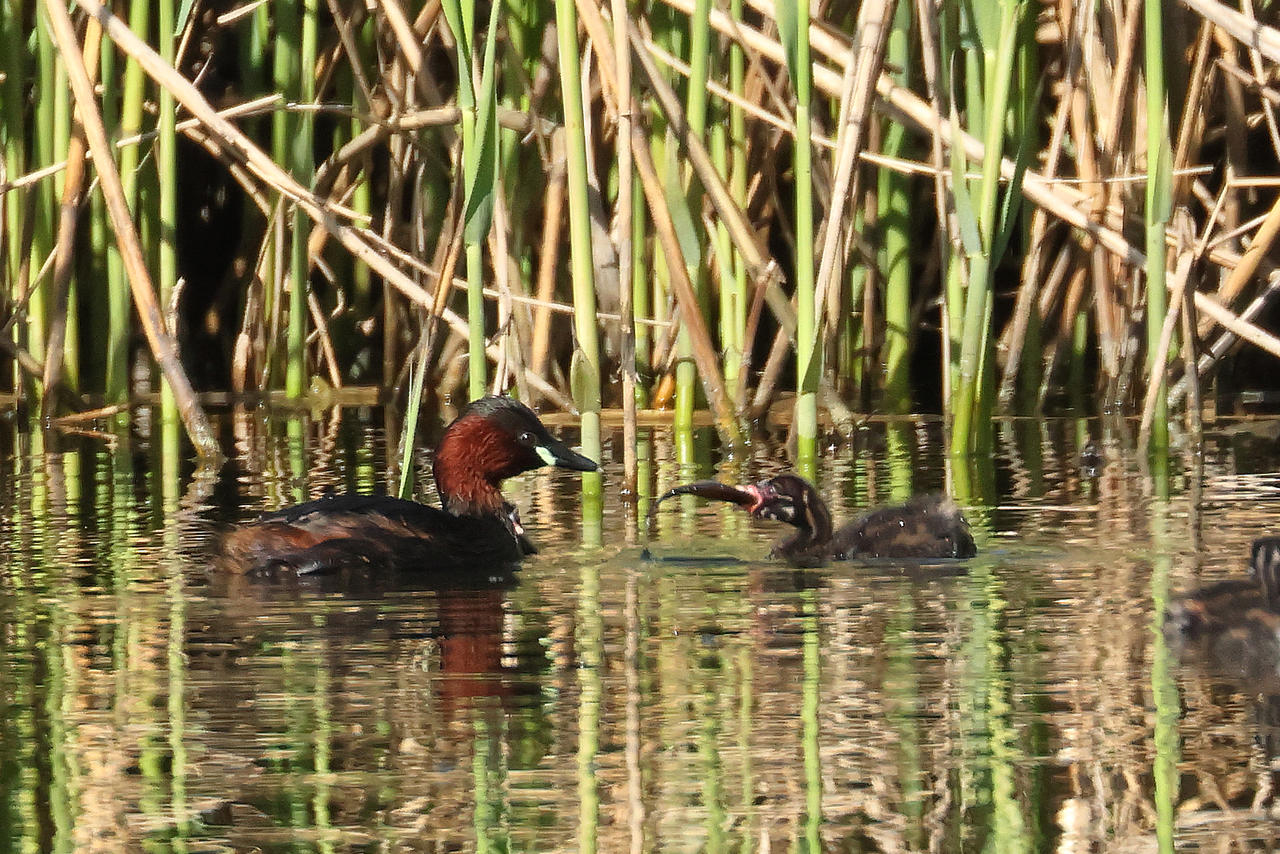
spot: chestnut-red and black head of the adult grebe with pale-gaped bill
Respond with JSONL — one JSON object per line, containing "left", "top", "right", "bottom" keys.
{"left": 433, "top": 397, "right": 598, "bottom": 515}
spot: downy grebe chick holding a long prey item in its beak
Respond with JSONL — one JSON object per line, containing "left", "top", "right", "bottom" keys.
{"left": 654, "top": 474, "right": 977, "bottom": 566}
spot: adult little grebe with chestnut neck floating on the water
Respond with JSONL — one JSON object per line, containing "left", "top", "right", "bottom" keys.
{"left": 223, "top": 397, "right": 596, "bottom": 575}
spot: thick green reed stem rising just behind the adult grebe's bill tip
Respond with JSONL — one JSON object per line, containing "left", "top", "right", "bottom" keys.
{"left": 556, "top": 0, "right": 600, "bottom": 494}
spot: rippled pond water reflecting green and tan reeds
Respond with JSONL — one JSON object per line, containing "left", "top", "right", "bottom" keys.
{"left": 0, "top": 410, "right": 1280, "bottom": 853}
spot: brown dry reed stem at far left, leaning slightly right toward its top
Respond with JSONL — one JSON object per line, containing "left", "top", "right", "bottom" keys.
{"left": 41, "top": 12, "right": 102, "bottom": 419}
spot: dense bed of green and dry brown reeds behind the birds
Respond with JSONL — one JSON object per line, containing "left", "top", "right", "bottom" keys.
{"left": 0, "top": 0, "right": 1280, "bottom": 463}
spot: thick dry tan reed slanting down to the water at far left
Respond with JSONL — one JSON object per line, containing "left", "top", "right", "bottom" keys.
{"left": 45, "top": 0, "right": 221, "bottom": 461}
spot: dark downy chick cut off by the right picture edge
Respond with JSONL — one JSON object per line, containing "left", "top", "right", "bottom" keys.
{"left": 1165, "top": 536, "right": 1280, "bottom": 680}
